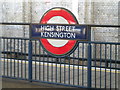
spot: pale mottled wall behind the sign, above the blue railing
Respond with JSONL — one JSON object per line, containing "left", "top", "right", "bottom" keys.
{"left": 0, "top": 0, "right": 119, "bottom": 42}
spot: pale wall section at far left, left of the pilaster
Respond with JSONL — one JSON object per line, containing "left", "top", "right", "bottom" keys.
{"left": 2, "top": 2, "right": 24, "bottom": 37}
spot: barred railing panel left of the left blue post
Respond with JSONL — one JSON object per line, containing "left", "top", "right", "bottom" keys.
{"left": 2, "top": 37, "right": 28, "bottom": 79}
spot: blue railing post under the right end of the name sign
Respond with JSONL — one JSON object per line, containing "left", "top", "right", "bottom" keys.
{"left": 87, "top": 42, "right": 92, "bottom": 88}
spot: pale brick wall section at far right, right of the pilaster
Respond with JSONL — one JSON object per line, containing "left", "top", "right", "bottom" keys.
{"left": 93, "top": 1, "right": 118, "bottom": 42}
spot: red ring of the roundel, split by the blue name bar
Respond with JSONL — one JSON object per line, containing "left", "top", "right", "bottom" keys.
{"left": 40, "top": 8, "right": 78, "bottom": 55}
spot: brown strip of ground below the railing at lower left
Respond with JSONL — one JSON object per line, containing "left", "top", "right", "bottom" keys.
{"left": 2, "top": 78, "right": 72, "bottom": 88}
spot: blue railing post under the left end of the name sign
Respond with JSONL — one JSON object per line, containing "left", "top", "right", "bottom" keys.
{"left": 28, "top": 40, "right": 32, "bottom": 82}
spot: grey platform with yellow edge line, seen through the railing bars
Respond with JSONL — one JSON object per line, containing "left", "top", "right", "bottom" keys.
{"left": 3, "top": 60, "right": 120, "bottom": 88}
